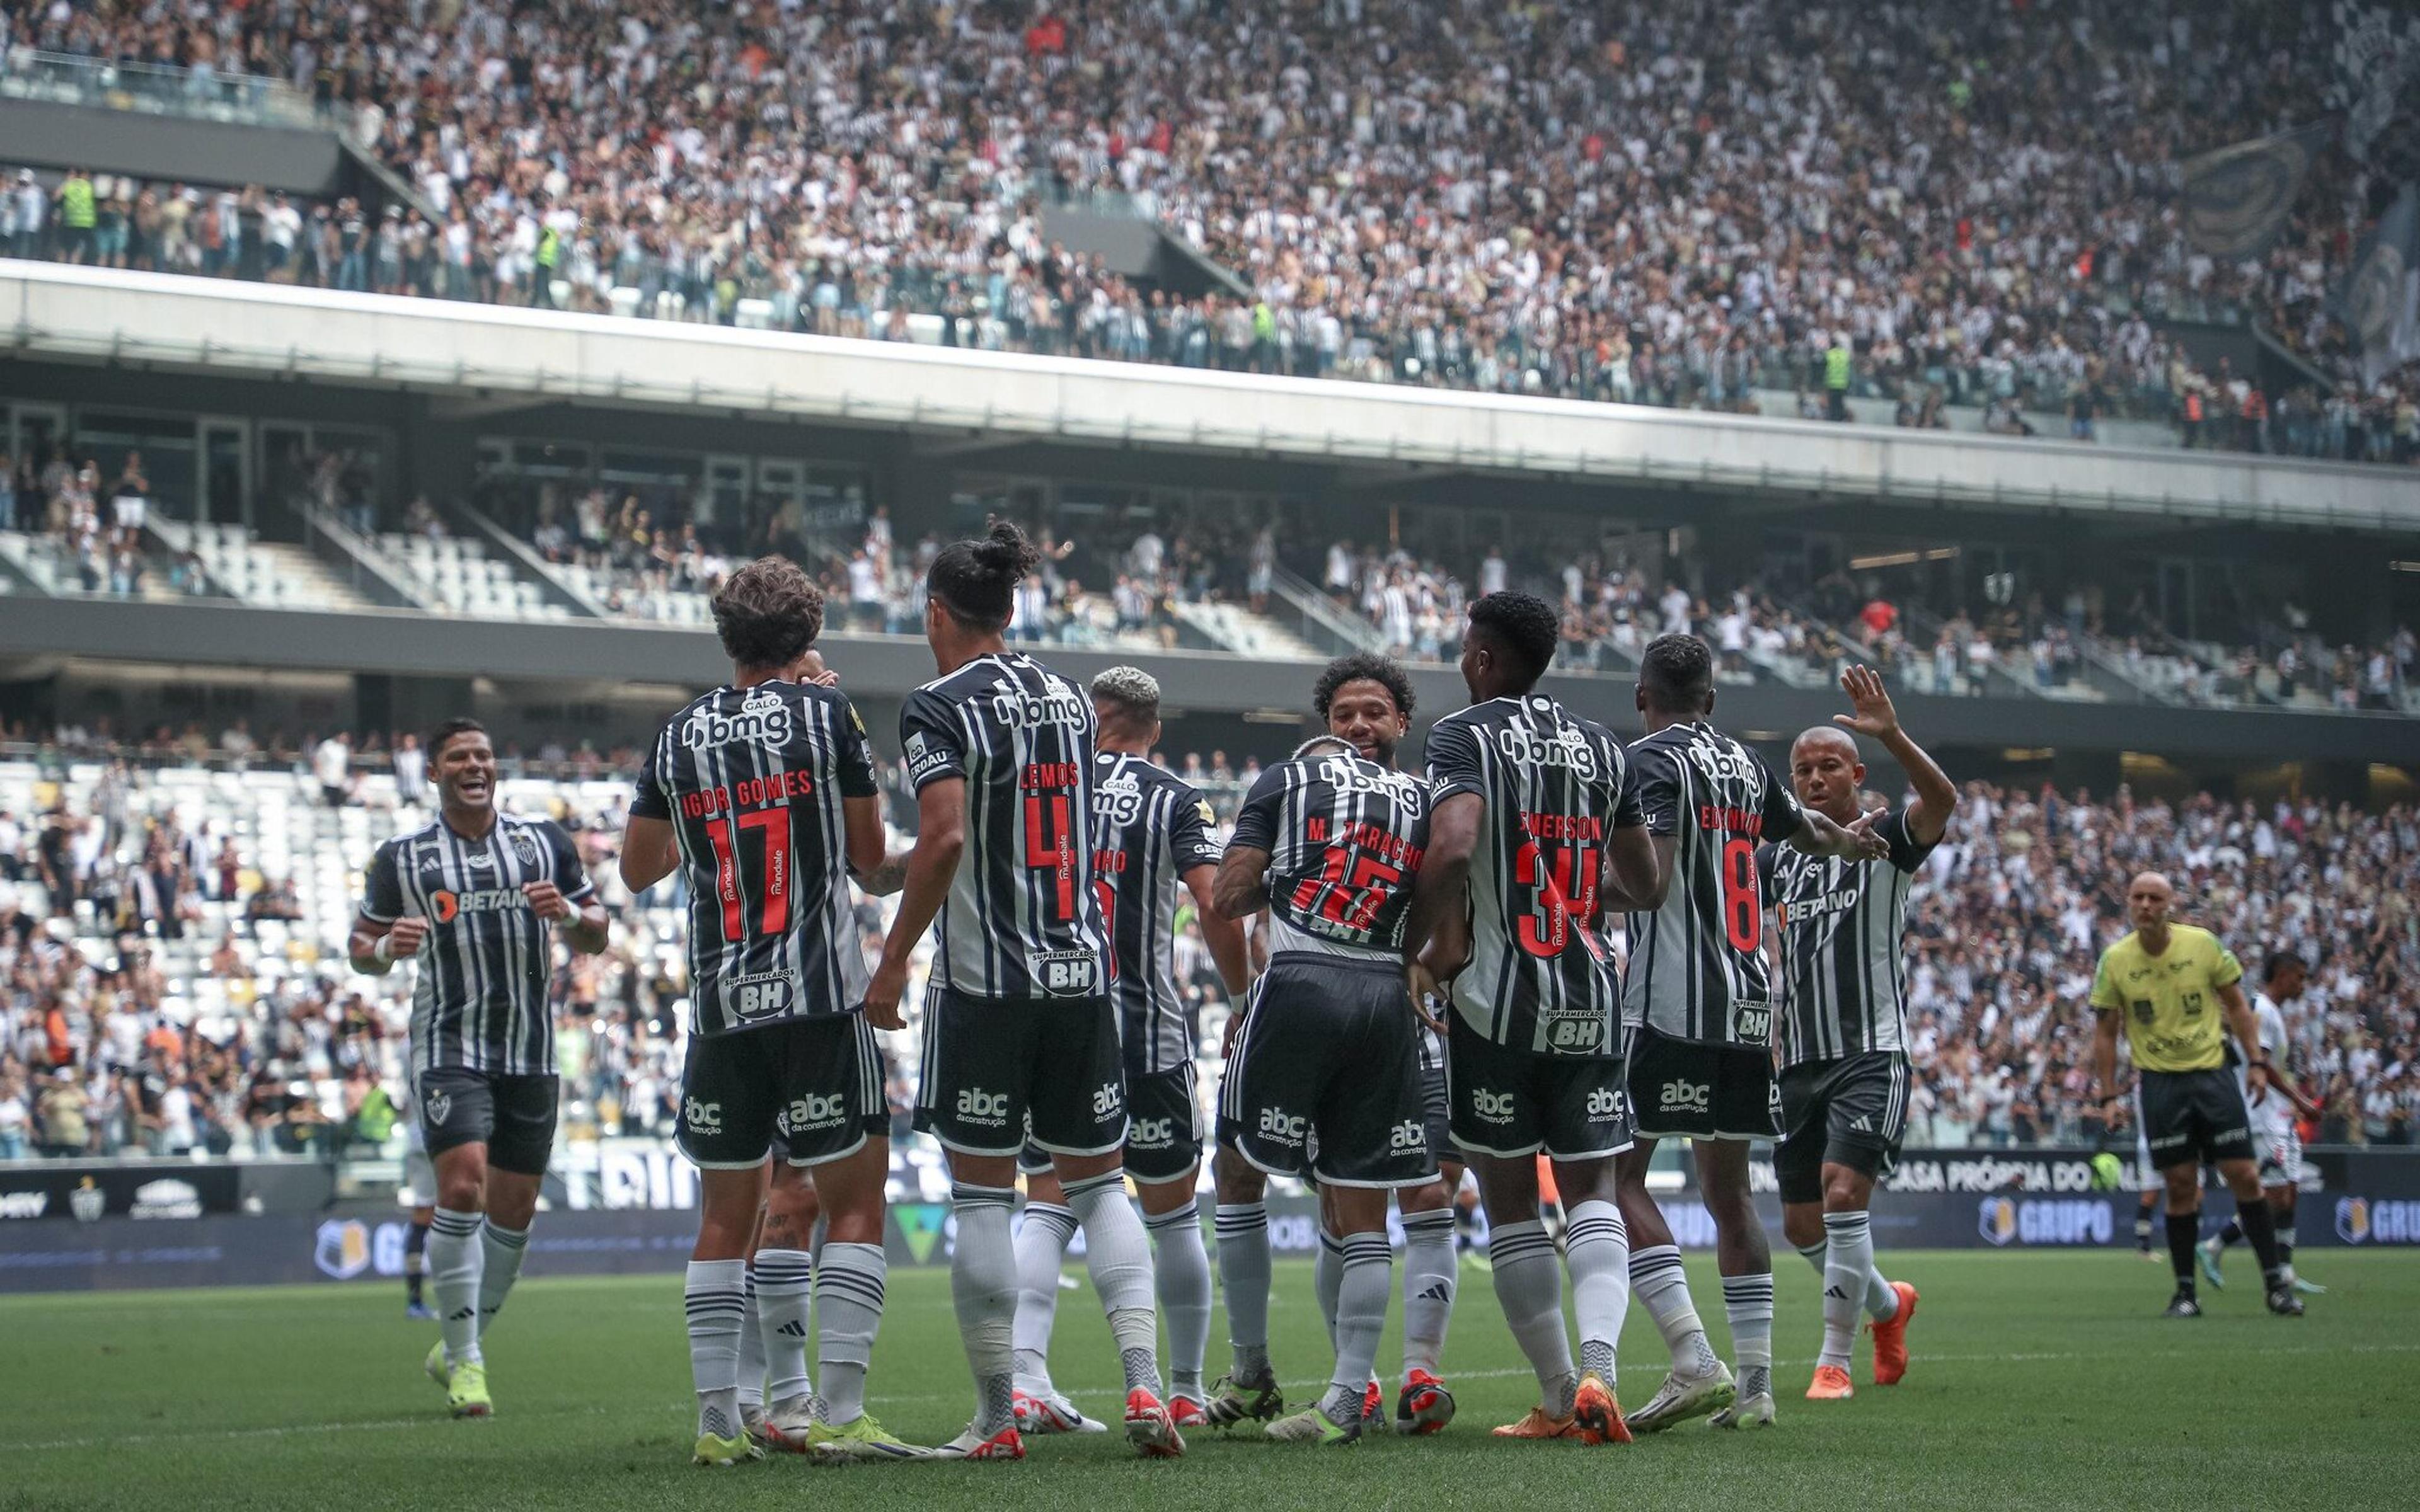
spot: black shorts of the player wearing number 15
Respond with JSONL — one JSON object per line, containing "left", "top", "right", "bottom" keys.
{"left": 1218, "top": 951, "right": 1438, "bottom": 1188}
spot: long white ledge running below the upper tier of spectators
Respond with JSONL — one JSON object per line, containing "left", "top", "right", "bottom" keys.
{"left": 0, "top": 261, "right": 2420, "bottom": 532}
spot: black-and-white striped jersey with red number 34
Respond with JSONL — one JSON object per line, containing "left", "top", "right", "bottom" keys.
{"left": 1428, "top": 692, "right": 1645, "bottom": 1055}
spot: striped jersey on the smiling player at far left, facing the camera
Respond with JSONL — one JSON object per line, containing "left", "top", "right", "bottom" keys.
{"left": 360, "top": 808, "right": 596, "bottom": 1077}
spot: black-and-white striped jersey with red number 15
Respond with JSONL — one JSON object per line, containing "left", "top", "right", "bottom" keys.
{"left": 1227, "top": 750, "right": 1428, "bottom": 960}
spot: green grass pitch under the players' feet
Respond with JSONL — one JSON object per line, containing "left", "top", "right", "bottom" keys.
{"left": 0, "top": 1251, "right": 2420, "bottom": 1512}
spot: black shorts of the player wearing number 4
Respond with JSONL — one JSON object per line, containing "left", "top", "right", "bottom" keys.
{"left": 915, "top": 987, "right": 1126, "bottom": 1154}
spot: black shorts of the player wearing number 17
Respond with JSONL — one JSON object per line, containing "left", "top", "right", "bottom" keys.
{"left": 677, "top": 1014, "right": 890, "bottom": 1171}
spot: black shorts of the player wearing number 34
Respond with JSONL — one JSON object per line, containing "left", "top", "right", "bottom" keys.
{"left": 1452, "top": 1014, "right": 1631, "bottom": 1161}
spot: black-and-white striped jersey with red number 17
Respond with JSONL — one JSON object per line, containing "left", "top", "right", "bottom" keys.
{"left": 629, "top": 680, "right": 876, "bottom": 1036}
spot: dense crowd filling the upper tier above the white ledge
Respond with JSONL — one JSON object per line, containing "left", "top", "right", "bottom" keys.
{"left": 0, "top": 0, "right": 2420, "bottom": 462}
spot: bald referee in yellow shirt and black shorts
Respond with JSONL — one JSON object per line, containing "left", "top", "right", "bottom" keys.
{"left": 2094, "top": 871, "right": 2302, "bottom": 1319}
